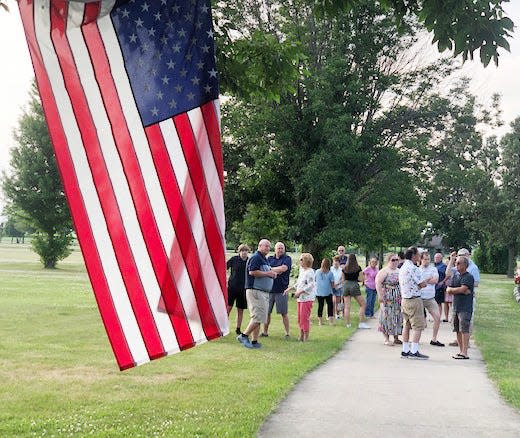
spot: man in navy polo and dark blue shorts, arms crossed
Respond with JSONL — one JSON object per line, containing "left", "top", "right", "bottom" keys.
{"left": 262, "top": 242, "right": 292, "bottom": 339}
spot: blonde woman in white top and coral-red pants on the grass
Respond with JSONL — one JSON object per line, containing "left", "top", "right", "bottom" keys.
{"left": 287, "top": 252, "right": 316, "bottom": 342}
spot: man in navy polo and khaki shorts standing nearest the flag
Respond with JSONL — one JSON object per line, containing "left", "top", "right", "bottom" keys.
{"left": 237, "top": 239, "right": 277, "bottom": 348}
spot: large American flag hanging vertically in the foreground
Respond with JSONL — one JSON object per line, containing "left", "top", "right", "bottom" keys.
{"left": 18, "top": 0, "right": 229, "bottom": 370}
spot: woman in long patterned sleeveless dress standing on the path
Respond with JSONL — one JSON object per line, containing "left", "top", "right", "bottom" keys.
{"left": 376, "top": 253, "right": 403, "bottom": 346}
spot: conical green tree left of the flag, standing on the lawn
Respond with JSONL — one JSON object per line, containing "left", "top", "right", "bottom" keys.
{"left": 2, "top": 86, "right": 72, "bottom": 268}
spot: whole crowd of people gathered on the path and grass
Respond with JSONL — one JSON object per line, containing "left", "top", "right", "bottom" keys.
{"left": 227, "top": 239, "right": 480, "bottom": 360}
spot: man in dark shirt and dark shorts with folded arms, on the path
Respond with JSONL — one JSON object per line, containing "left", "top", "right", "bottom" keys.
{"left": 446, "top": 256, "right": 475, "bottom": 359}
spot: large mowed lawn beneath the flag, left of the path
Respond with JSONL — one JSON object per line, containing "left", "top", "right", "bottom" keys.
{"left": 0, "top": 240, "right": 357, "bottom": 437}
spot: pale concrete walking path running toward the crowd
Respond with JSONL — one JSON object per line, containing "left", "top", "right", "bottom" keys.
{"left": 259, "top": 319, "right": 520, "bottom": 438}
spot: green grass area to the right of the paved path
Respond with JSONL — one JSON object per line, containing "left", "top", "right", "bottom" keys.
{"left": 475, "top": 275, "right": 520, "bottom": 410}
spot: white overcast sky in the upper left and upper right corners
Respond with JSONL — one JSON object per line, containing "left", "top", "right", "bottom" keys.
{"left": 0, "top": 0, "right": 520, "bottom": 214}
